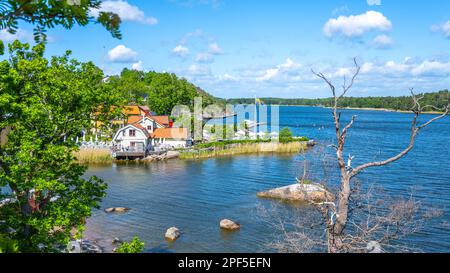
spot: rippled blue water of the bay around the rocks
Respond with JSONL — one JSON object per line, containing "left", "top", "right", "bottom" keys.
{"left": 86, "top": 107, "right": 450, "bottom": 252}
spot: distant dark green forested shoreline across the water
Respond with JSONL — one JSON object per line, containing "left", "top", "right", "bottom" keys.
{"left": 227, "top": 90, "right": 450, "bottom": 111}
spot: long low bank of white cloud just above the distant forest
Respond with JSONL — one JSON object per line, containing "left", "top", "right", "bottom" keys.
{"left": 176, "top": 56, "right": 450, "bottom": 97}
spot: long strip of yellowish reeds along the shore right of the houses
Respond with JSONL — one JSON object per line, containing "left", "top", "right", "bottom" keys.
{"left": 180, "top": 140, "right": 308, "bottom": 159}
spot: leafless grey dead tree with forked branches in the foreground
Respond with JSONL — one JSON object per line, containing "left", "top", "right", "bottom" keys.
{"left": 312, "top": 58, "right": 450, "bottom": 253}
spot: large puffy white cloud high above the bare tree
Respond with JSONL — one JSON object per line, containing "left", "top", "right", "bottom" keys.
{"left": 323, "top": 11, "right": 392, "bottom": 38}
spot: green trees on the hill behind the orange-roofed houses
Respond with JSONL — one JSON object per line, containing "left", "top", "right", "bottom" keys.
{"left": 109, "top": 69, "right": 219, "bottom": 115}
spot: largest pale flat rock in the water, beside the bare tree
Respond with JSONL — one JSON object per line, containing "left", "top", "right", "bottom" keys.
{"left": 257, "top": 183, "right": 335, "bottom": 202}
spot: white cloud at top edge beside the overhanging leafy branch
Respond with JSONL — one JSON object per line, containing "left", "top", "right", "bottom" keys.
{"left": 90, "top": 0, "right": 158, "bottom": 25}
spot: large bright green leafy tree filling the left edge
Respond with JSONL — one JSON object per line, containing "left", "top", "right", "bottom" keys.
{"left": 0, "top": 41, "right": 123, "bottom": 252}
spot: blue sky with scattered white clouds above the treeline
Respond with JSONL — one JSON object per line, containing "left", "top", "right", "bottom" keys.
{"left": 0, "top": 0, "right": 450, "bottom": 98}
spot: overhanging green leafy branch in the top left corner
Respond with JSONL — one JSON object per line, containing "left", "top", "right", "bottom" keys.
{"left": 0, "top": 0, "right": 122, "bottom": 43}
